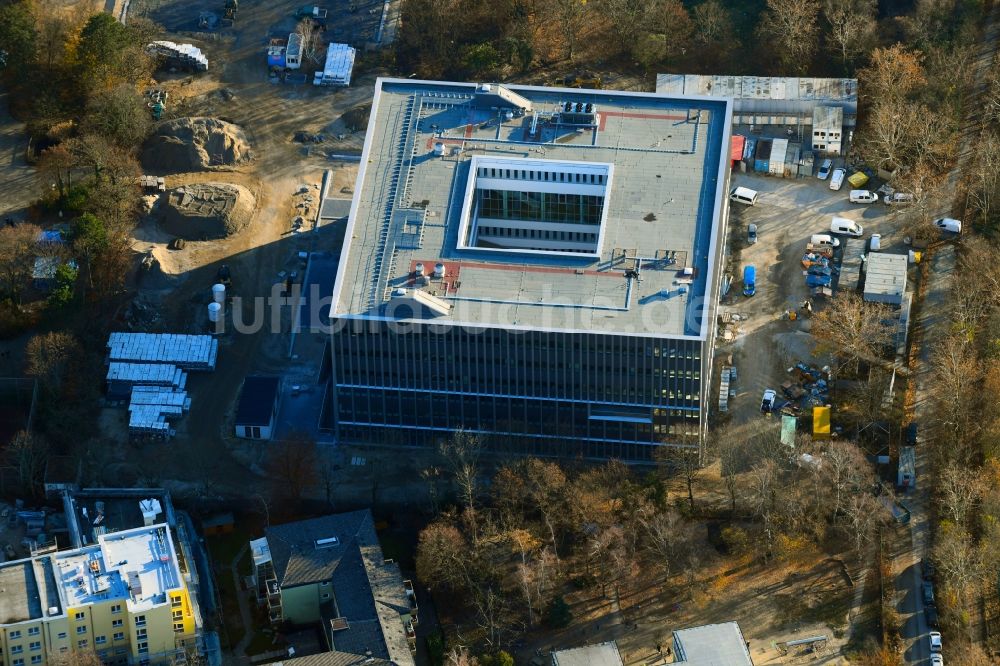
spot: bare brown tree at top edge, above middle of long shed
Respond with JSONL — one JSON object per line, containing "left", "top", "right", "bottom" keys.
{"left": 757, "top": 0, "right": 819, "bottom": 74}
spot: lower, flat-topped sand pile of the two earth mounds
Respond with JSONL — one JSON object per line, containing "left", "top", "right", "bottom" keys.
{"left": 160, "top": 183, "right": 256, "bottom": 241}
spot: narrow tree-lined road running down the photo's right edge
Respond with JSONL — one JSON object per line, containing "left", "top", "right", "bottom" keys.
{"left": 894, "top": 5, "right": 1000, "bottom": 664}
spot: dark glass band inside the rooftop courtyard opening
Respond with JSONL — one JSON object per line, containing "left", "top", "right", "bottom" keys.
{"left": 476, "top": 190, "right": 604, "bottom": 226}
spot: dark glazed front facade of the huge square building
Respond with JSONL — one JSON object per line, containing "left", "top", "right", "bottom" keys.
{"left": 329, "top": 322, "right": 705, "bottom": 461}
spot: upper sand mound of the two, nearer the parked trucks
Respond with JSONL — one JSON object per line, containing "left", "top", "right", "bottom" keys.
{"left": 143, "top": 118, "right": 253, "bottom": 173}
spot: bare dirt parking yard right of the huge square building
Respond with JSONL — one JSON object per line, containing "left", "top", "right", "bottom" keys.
{"left": 718, "top": 173, "right": 907, "bottom": 422}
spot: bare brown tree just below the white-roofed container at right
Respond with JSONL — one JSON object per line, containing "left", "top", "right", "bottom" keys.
{"left": 811, "top": 293, "right": 895, "bottom": 368}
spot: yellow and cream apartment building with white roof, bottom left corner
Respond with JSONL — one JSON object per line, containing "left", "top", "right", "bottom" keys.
{"left": 0, "top": 524, "right": 199, "bottom": 666}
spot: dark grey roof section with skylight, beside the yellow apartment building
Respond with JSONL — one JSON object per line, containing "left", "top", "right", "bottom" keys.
{"left": 264, "top": 509, "right": 375, "bottom": 587}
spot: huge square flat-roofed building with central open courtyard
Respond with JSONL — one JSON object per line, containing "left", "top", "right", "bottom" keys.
{"left": 325, "top": 79, "right": 732, "bottom": 461}
